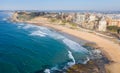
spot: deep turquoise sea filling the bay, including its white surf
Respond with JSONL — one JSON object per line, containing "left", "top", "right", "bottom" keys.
{"left": 0, "top": 12, "right": 88, "bottom": 73}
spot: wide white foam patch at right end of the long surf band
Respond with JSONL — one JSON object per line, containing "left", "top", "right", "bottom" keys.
{"left": 63, "top": 38, "right": 88, "bottom": 52}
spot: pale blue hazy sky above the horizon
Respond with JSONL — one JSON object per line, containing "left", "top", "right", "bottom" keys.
{"left": 0, "top": 0, "right": 120, "bottom": 10}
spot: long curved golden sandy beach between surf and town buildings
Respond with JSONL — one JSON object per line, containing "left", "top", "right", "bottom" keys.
{"left": 20, "top": 18, "right": 120, "bottom": 73}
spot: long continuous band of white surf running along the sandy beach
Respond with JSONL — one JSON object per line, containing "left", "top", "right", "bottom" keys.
{"left": 19, "top": 24, "right": 87, "bottom": 52}
